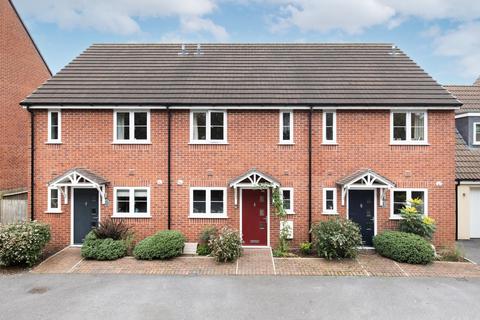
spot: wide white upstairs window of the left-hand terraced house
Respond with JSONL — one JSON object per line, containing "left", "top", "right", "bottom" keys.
{"left": 114, "top": 111, "right": 150, "bottom": 143}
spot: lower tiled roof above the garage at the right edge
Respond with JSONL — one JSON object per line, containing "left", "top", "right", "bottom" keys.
{"left": 455, "top": 131, "right": 480, "bottom": 180}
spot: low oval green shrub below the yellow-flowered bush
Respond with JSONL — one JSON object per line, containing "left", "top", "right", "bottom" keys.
{"left": 373, "top": 231, "right": 435, "bottom": 264}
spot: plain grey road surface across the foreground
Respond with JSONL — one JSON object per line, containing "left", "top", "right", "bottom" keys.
{"left": 0, "top": 273, "right": 480, "bottom": 320}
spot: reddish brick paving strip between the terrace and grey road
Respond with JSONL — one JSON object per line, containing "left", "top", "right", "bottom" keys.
{"left": 31, "top": 248, "right": 480, "bottom": 278}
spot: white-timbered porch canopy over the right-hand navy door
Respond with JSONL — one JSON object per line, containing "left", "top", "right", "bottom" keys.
{"left": 337, "top": 169, "right": 395, "bottom": 206}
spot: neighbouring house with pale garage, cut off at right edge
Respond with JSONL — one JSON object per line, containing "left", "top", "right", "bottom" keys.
{"left": 445, "top": 78, "right": 480, "bottom": 239}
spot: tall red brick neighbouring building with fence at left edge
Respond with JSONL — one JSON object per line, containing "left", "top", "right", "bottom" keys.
{"left": 0, "top": 0, "right": 52, "bottom": 223}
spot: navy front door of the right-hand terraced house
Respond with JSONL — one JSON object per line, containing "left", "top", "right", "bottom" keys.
{"left": 348, "top": 190, "right": 375, "bottom": 246}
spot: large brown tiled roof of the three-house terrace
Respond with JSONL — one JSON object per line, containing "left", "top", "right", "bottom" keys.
{"left": 22, "top": 44, "right": 460, "bottom": 108}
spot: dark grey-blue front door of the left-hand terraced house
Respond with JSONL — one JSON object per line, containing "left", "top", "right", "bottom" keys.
{"left": 73, "top": 189, "right": 98, "bottom": 244}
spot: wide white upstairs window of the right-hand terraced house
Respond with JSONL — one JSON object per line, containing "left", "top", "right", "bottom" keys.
{"left": 391, "top": 111, "right": 427, "bottom": 144}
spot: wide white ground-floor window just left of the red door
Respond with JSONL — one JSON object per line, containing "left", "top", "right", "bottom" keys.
{"left": 190, "top": 188, "right": 227, "bottom": 218}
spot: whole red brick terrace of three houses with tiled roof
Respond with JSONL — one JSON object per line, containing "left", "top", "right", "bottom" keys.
{"left": 21, "top": 44, "right": 460, "bottom": 249}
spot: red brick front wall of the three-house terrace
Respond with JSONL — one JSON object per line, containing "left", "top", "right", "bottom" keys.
{"left": 31, "top": 110, "right": 455, "bottom": 254}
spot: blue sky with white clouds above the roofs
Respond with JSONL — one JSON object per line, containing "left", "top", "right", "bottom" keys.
{"left": 13, "top": 0, "right": 480, "bottom": 84}
